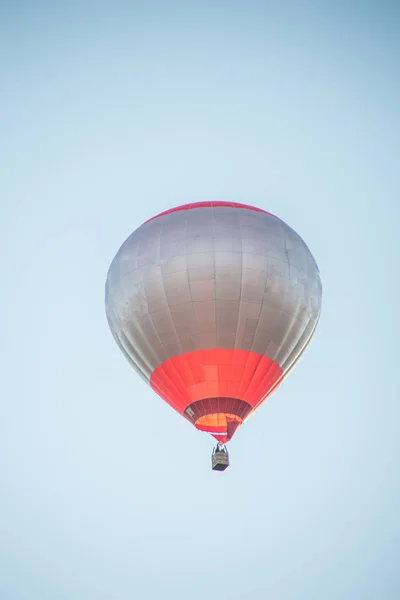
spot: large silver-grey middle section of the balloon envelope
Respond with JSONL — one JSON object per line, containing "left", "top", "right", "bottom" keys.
{"left": 106, "top": 206, "right": 322, "bottom": 380}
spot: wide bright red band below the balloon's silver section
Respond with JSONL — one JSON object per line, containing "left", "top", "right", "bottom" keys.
{"left": 150, "top": 348, "right": 283, "bottom": 414}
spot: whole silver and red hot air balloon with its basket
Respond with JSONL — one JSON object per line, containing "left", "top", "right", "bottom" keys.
{"left": 105, "top": 202, "right": 322, "bottom": 470}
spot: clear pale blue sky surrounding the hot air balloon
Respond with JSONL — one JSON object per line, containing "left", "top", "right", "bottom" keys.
{"left": 0, "top": 0, "right": 400, "bottom": 600}
